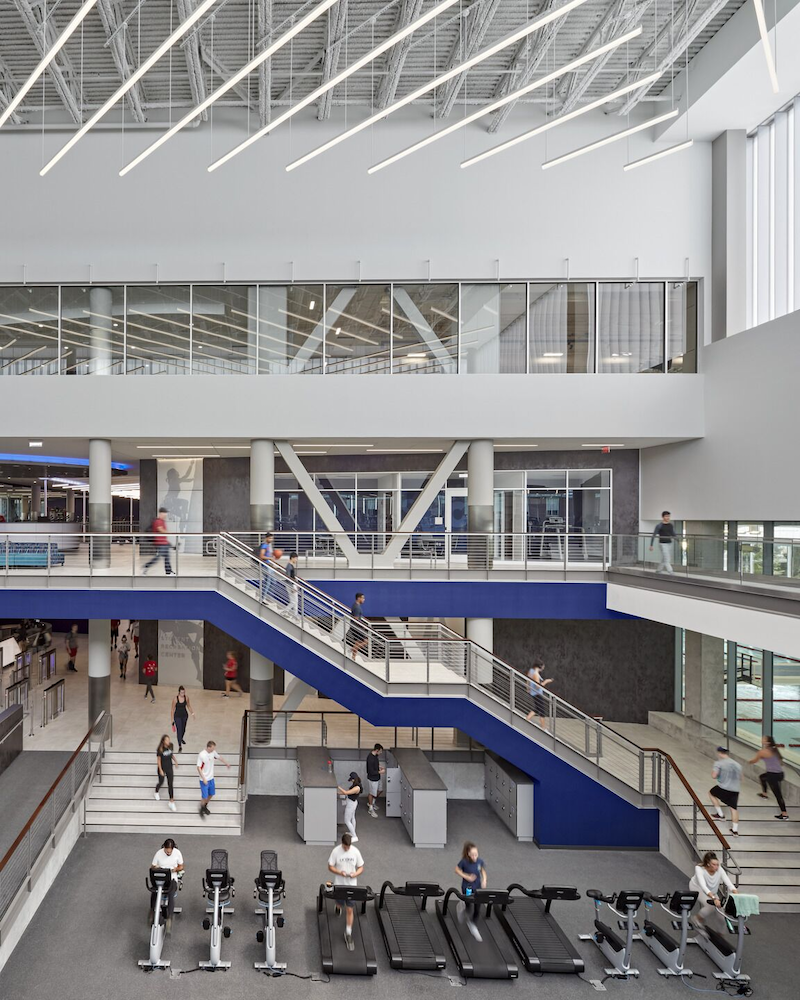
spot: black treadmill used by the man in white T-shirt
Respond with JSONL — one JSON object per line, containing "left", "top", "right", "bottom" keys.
{"left": 317, "top": 883, "right": 378, "bottom": 976}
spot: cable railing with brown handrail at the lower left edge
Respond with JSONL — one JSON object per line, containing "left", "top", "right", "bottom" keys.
{"left": 0, "top": 712, "right": 111, "bottom": 920}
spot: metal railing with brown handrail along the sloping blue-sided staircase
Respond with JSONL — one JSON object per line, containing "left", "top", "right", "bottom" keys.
{"left": 217, "top": 534, "right": 735, "bottom": 867}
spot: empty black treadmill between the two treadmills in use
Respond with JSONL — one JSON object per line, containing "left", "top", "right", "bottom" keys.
{"left": 375, "top": 882, "right": 447, "bottom": 970}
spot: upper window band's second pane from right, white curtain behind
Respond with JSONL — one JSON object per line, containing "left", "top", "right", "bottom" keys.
{"left": 597, "top": 281, "right": 664, "bottom": 373}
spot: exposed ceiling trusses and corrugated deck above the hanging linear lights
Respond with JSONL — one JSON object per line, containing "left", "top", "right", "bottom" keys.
{"left": 0, "top": 0, "right": 744, "bottom": 132}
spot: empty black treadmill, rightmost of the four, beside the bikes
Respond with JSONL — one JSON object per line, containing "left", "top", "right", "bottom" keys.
{"left": 497, "top": 882, "right": 584, "bottom": 973}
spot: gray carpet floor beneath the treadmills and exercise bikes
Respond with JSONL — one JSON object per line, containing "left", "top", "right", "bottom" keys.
{"left": 0, "top": 797, "right": 800, "bottom": 1000}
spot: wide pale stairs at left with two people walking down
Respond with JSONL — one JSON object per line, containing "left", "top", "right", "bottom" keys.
{"left": 86, "top": 750, "right": 242, "bottom": 837}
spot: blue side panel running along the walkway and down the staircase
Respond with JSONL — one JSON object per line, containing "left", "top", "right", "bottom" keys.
{"left": 0, "top": 590, "right": 659, "bottom": 850}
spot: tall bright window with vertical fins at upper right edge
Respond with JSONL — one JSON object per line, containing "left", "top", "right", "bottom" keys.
{"left": 747, "top": 97, "right": 800, "bottom": 326}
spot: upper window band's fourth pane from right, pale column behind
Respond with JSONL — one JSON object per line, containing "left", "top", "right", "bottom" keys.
{"left": 461, "top": 284, "right": 527, "bottom": 374}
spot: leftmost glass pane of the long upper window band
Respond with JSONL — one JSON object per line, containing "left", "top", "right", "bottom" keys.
{"left": 0, "top": 286, "right": 64, "bottom": 375}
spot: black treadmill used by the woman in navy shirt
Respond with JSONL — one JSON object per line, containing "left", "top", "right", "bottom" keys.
{"left": 436, "top": 889, "right": 519, "bottom": 979}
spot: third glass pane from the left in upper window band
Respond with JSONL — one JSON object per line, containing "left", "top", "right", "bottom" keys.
{"left": 125, "top": 285, "right": 192, "bottom": 375}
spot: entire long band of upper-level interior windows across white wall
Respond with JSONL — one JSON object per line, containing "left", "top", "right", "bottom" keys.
{"left": 0, "top": 279, "right": 697, "bottom": 375}
